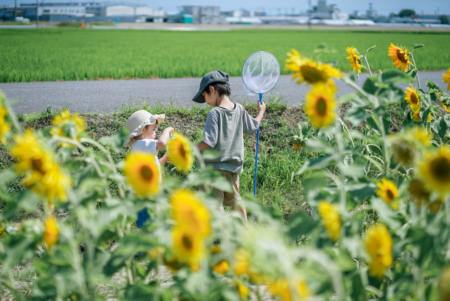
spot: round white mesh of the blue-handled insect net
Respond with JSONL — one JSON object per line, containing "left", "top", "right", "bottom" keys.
{"left": 242, "top": 51, "right": 280, "bottom": 94}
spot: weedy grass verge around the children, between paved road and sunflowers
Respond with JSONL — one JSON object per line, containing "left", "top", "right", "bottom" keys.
{"left": 0, "top": 103, "right": 306, "bottom": 217}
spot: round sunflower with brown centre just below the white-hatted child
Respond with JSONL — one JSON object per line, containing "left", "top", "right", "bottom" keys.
{"left": 124, "top": 152, "right": 161, "bottom": 197}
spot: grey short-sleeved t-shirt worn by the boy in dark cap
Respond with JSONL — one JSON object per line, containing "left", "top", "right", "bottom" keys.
{"left": 203, "top": 103, "right": 259, "bottom": 173}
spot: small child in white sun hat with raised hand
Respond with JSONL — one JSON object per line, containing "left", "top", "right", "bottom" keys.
{"left": 127, "top": 110, "right": 174, "bottom": 164}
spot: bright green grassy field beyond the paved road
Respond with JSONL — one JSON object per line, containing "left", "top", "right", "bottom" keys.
{"left": 0, "top": 28, "right": 450, "bottom": 82}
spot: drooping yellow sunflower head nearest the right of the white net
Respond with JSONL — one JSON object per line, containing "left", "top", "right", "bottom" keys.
{"left": 286, "top": 49, "right": 342, "bottom": 85}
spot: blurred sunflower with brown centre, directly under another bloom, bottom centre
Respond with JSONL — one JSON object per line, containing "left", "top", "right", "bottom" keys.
{"left": 172, "top": 227, "right": 205, "bottom": 271}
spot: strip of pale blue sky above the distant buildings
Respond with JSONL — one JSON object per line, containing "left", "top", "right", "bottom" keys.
{"left": 0, "top": 0, "right": 450, "bottom": 15}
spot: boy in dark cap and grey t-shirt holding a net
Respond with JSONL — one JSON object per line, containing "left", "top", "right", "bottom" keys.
{"left": 192, "top": 70, "right": 266, "bottom": 221}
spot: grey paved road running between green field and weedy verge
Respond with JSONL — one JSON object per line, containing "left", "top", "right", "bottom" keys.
{"left": 0, "top": 71, "right": 445, "bottom": 113}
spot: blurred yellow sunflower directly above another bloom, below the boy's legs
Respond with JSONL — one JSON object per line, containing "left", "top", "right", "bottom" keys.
{"left": 170, "top": 189, "right": 211, "bottom": 237}
